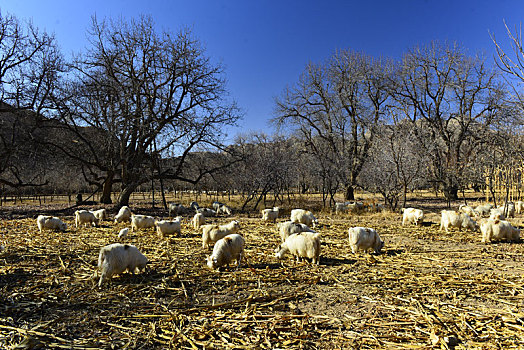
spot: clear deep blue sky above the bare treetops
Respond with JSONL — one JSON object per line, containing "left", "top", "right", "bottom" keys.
{"left": 0, "top": 0, "right": 524, "bottom": 136}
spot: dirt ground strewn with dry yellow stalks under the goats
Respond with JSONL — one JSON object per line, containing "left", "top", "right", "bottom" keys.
{"left": 0, "top": 198, "right": 524, "bottom": 349}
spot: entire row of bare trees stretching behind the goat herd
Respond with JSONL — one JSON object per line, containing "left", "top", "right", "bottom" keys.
{"left": 0, "top": 9, "right": 524, "bottom": 208}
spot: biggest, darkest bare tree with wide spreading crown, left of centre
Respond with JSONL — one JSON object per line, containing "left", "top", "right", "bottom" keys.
{"left": 47, "top": 17, "right": 240, "bottom": 205}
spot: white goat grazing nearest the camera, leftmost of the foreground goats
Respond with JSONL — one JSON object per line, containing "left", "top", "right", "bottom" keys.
{"left": 98, "top": 243, "right": 147, "bottom": 287}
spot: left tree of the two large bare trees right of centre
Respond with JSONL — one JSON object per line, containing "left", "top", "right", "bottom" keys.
{"left": 273, "top": 51, "right": 388, "bottom": 199}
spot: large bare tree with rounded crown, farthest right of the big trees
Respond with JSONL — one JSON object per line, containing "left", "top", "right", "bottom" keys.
{"left": 393, "top": 43, "right": 504, "bottom": 200}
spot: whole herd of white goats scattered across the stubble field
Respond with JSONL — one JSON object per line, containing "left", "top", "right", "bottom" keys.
{"left": 32, "top": 198, "right": 524, "bottom": 287}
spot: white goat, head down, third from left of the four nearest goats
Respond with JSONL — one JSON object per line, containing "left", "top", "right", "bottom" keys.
{"left": 275, "top": 232, "right": 320, "bottom": 265}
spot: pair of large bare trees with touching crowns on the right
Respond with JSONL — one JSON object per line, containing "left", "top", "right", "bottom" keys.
{"left": 274, "top": 43, "right": 511, "bottom": 204}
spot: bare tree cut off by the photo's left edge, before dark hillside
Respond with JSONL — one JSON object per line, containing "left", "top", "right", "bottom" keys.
{"left": 0, "top": 13, "right": 62, "bottom": 187}
